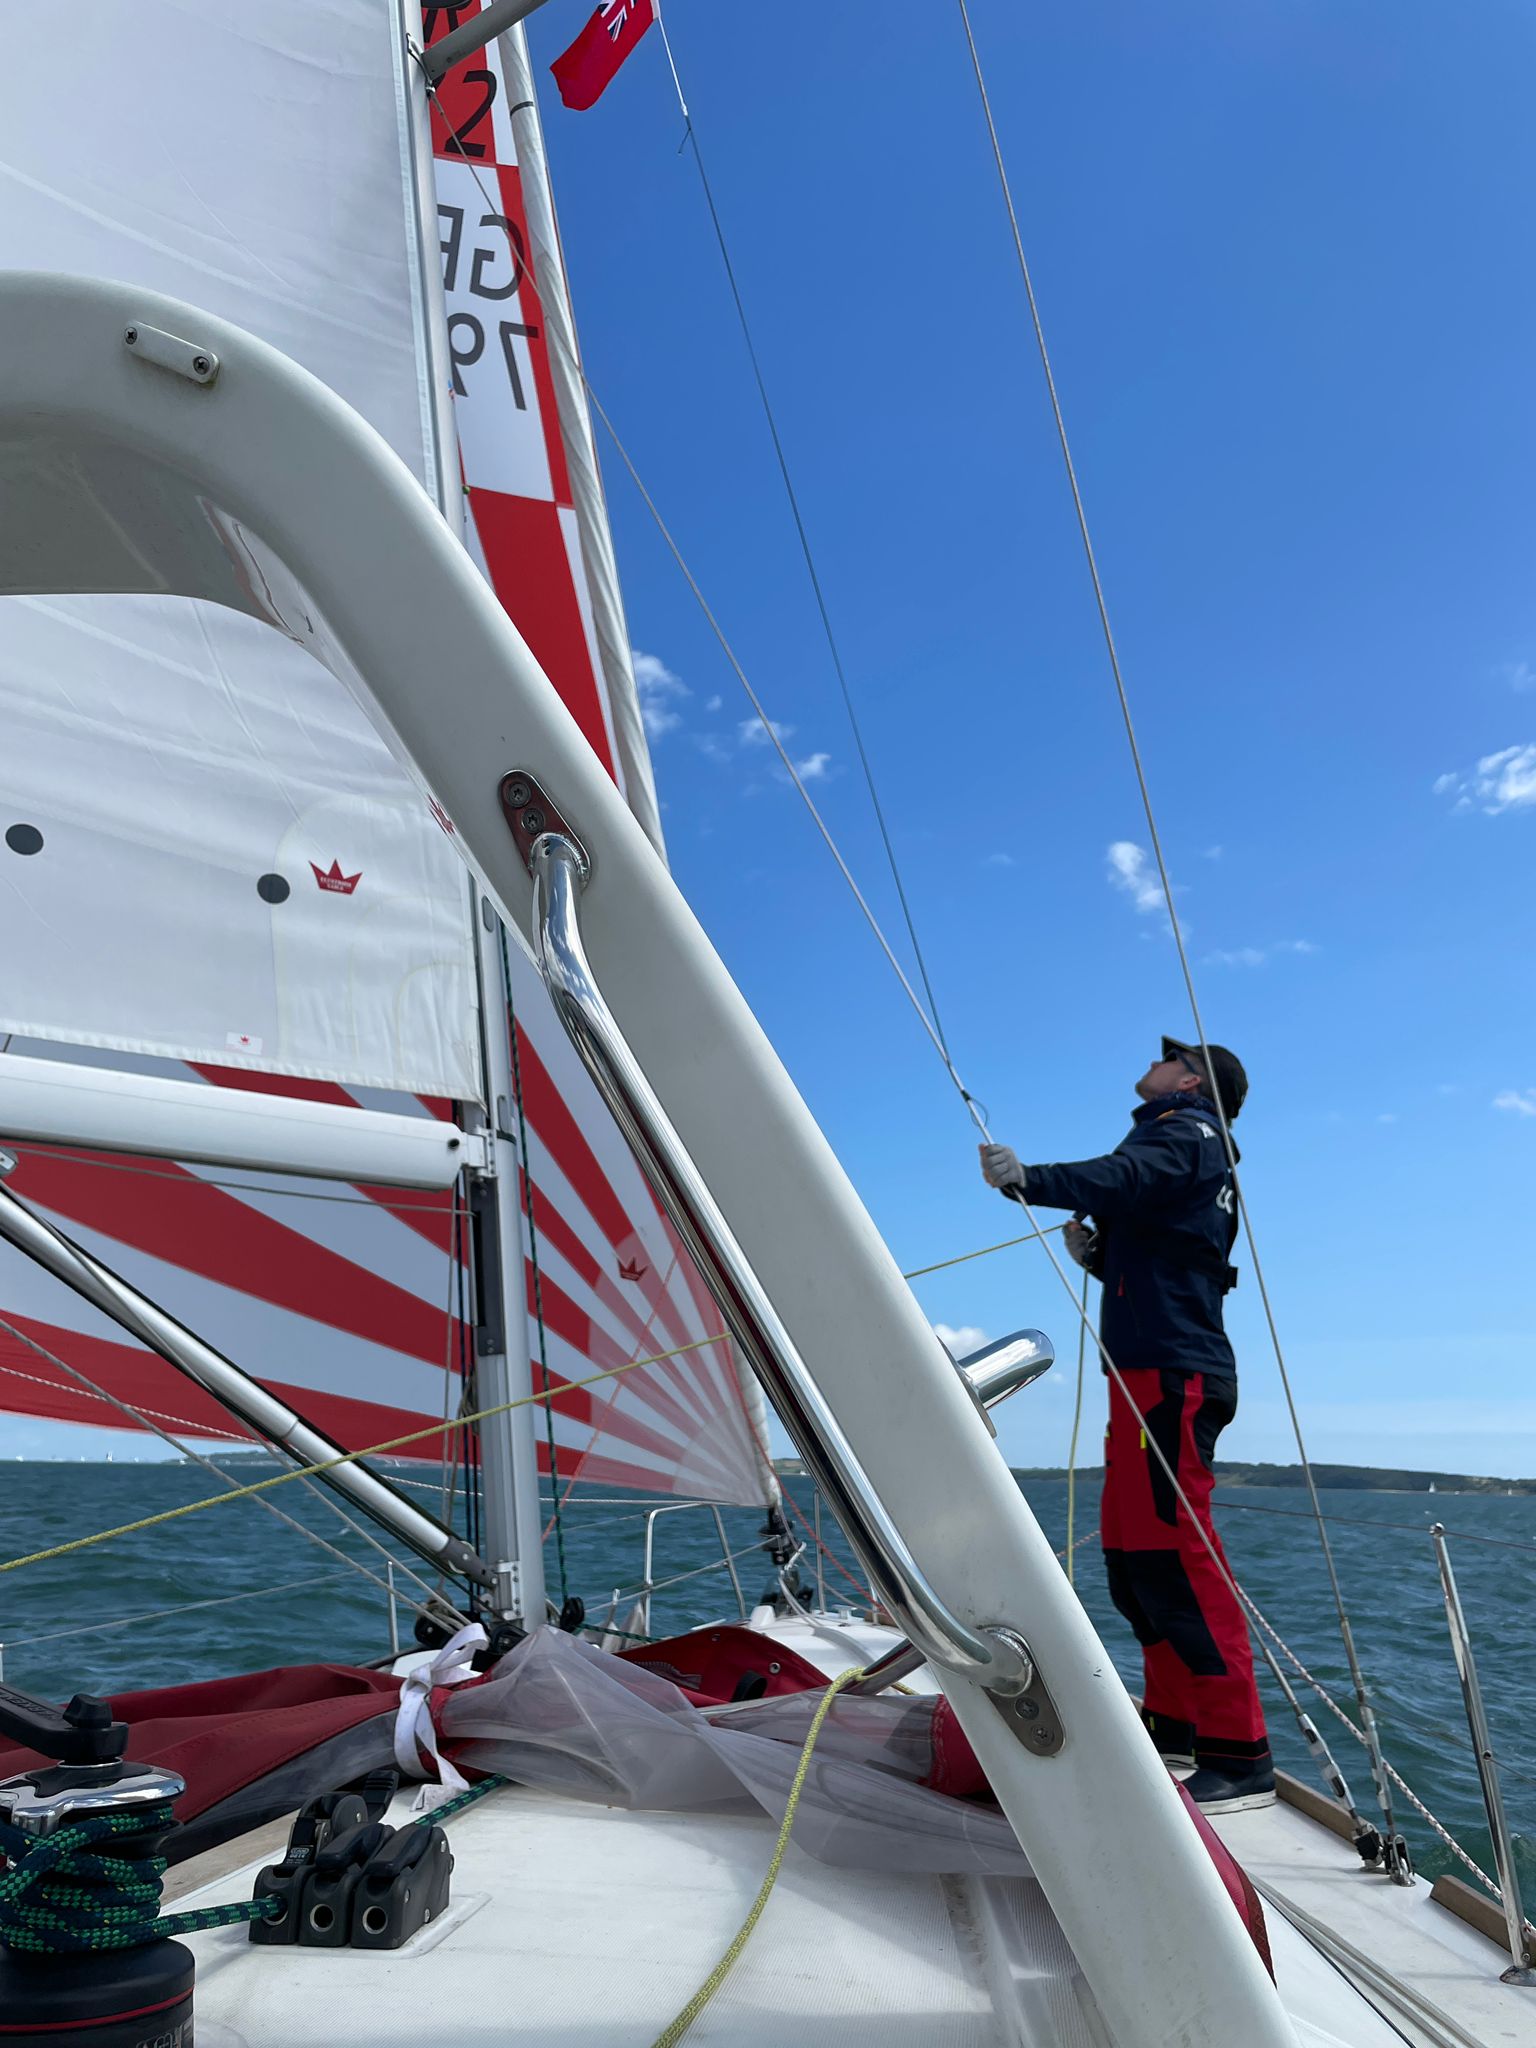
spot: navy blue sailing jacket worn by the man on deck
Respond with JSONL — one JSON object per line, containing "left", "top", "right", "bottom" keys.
{"left": 1024, "top": 1096, "right": 1237, "bottom": 1380}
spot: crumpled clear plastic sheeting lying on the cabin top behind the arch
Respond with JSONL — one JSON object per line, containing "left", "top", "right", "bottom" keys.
{"left": 438, "top": 1628, "right": 1030, "bottom": 1878}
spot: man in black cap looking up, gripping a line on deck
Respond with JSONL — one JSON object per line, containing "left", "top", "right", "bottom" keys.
{"left": 981, "top": 1038, "right": 1274, "bottom": 1812}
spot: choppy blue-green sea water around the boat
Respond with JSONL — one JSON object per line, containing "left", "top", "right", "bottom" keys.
{"left": 0, "top": 1458, "right": 1536, "bottom": 1911}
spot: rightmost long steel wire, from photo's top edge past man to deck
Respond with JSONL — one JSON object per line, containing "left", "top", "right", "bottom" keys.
{"left": 958, "top": 0, "right": 1397, "bottom": 1858}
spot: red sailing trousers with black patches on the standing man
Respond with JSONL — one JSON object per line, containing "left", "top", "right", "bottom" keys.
{"left": 1100, "top": 1368, "right": 1270, "bottom": 1769}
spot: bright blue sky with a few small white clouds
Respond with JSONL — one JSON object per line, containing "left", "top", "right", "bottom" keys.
{"left": 15, "top": 0, "right": 1536, "bottom": 1475}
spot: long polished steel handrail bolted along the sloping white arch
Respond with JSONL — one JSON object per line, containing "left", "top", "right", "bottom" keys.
{"left": 528, "top": 831, "right": 1032, "bottom": 1694}
